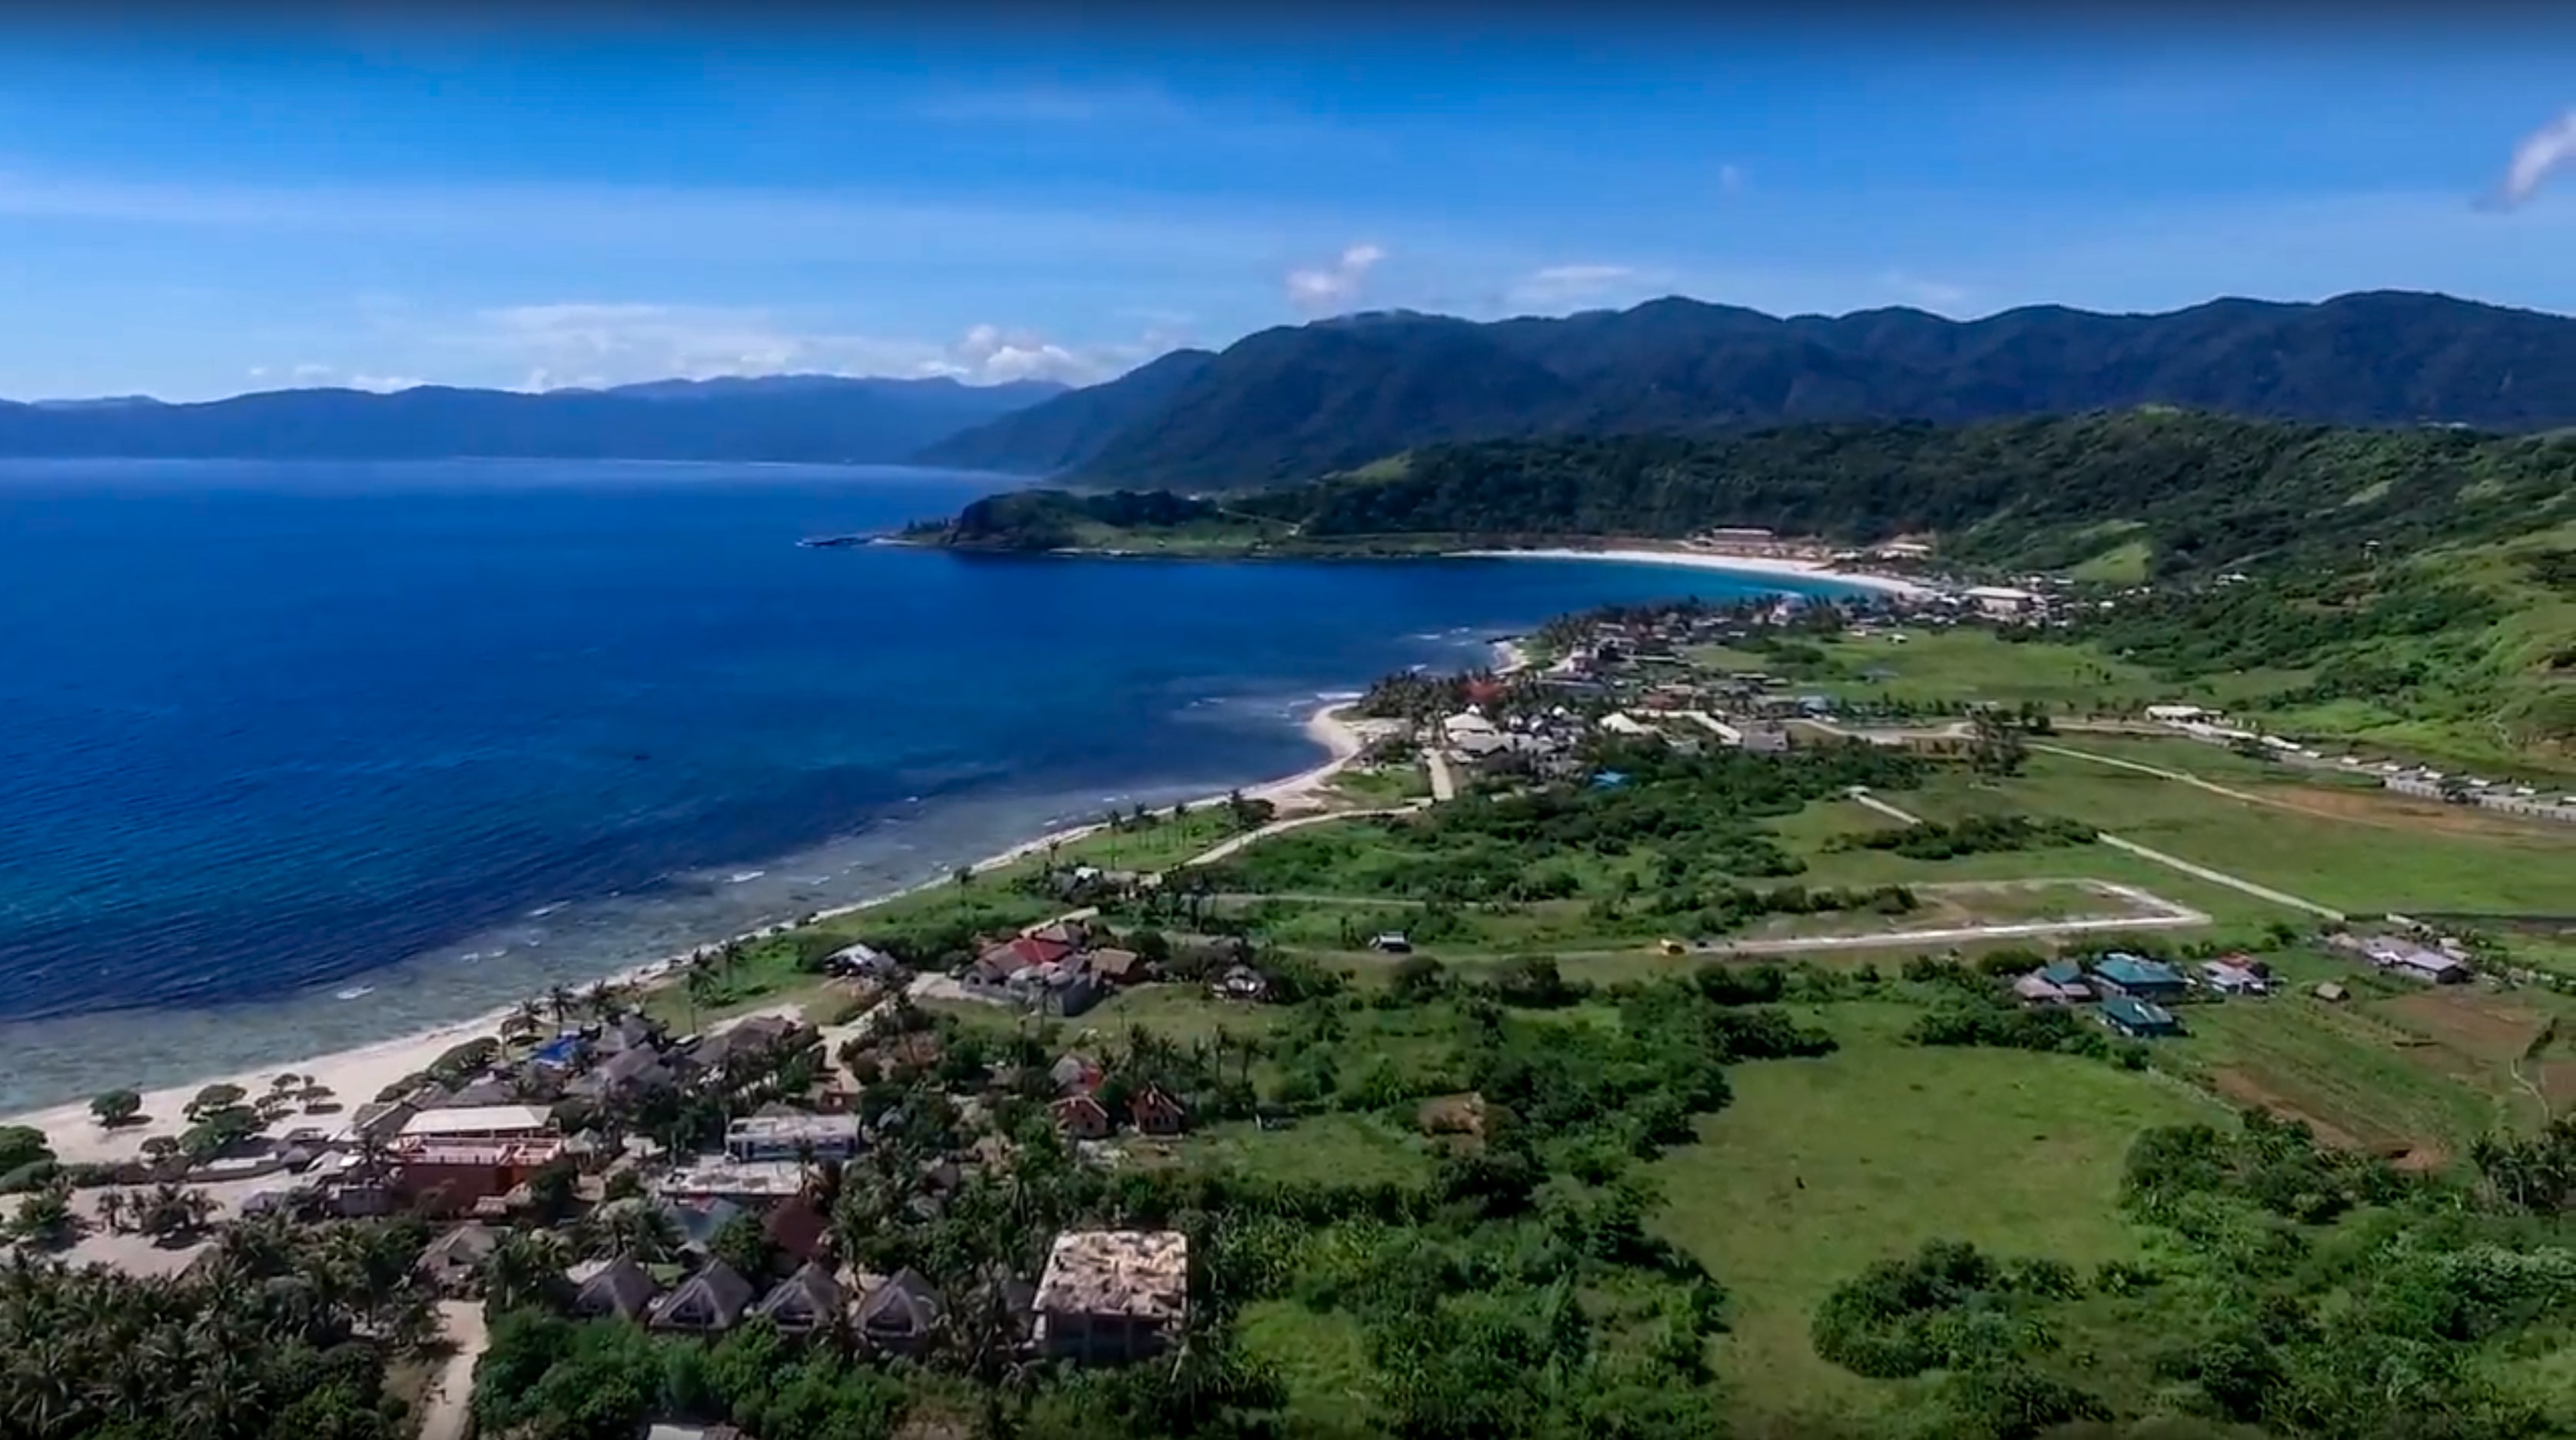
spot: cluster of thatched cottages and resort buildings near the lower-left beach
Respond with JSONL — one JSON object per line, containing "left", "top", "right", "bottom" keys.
{"left": 368, "top": 1017, "right": 1187, "bottom": 1362}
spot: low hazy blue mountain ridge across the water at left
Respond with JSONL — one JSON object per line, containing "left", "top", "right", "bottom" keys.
{"left": 0, "top": 376, "right": 1064, "bottom": 463}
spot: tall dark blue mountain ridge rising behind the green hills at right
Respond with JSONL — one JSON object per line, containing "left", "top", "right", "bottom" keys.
{"left": 925, "top": 291, "right": 2576, "bottom": 489}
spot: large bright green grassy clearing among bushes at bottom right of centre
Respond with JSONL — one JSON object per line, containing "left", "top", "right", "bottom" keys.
{"left": 1651, "top": 1002, "right": 2223, "bottom": 1419}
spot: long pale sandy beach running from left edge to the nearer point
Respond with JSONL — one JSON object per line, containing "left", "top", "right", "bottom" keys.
{"left": 0, "top": 698, "right": 1368, "bottom": 1164}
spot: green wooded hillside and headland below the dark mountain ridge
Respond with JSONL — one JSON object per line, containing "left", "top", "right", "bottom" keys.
{"left": 927, "top": 410, "right": 2576, "bottom": 760}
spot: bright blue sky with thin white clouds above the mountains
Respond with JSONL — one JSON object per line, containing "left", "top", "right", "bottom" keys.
{"left": 0, "top": 5, "right": 2576, "bottom": 400}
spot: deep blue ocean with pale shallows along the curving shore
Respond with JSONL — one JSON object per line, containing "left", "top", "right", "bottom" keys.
{"left": 0, "top": 461, "right": 1854, "bottom": 1110}
